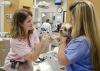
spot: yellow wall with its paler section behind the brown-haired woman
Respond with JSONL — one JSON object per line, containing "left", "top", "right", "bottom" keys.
{"left": 4, "top": 0, "right": 33, "bottom": 32}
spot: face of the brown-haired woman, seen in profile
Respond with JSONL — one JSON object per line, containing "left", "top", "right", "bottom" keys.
{"left": 22, "top": 15, "right": 33, "bottom": 32}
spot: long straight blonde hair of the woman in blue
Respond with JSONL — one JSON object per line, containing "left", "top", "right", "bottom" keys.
{"left": 70, "top": 0, "right": 100, "bottom": 71}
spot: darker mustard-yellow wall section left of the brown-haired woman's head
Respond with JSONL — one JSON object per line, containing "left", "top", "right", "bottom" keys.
{"left": 4, "top": 0, "right": 19, "bottom": 32}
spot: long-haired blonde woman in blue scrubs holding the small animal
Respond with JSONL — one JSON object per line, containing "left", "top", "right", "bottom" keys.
{"left": 58, "top": 0, "right": 100, "bottom": 71}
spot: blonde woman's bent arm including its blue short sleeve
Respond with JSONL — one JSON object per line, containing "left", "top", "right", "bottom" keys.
{"left": 59, "top": 38, "right": 90, "bottom": 65}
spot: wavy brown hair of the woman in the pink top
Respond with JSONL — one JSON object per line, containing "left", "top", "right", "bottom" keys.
{"left": 10, "top": 9, "right": 33, "bottom": 39}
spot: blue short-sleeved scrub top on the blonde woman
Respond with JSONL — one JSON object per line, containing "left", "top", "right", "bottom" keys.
{"left": 64, "top": 36, "right": 93, "bottom": 71}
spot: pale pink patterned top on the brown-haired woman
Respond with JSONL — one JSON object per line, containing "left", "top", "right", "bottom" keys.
{"left": 5, "top": 29, "right": 39, "bottom": 65}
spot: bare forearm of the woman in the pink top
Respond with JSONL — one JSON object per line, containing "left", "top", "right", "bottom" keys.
{"left": 24, "top": 36, "right": 50, "bottom": 61}
